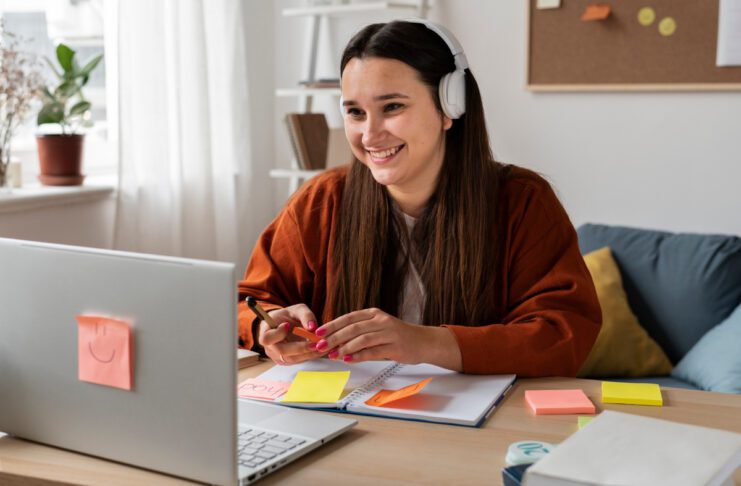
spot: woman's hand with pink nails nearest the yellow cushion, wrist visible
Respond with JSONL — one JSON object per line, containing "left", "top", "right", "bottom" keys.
{"left": 316, "top": 309, "right": 462, "bottom": 370}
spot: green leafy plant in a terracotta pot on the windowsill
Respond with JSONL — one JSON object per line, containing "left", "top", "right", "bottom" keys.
{"left": 36, "top": 44, "right": 103, "bottom": 186}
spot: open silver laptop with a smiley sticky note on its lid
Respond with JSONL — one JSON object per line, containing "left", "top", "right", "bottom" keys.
{"left": 0, "top": 238, "right": 356, "bottom": 485}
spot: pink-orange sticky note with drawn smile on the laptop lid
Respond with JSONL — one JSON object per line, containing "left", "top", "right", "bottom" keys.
{"left": 75, "top": 316, "right": 133, "bottom": 390}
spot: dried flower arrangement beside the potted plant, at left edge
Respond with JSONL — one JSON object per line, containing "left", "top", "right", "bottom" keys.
{"left": 0, "top": 19, "right": 43, "bottom": 187}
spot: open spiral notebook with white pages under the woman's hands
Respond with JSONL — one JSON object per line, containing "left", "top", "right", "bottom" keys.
{"left": 251, "top": 359, "right": 515, "bottom": 427}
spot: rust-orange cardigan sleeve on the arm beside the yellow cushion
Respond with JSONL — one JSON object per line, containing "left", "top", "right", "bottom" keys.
{"left": 446, "top": 175, "right": 602, "bottom": 377}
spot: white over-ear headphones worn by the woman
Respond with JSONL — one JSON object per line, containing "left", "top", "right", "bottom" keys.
{"left": 405, "top": 19, "right": 468, "bottom": 120}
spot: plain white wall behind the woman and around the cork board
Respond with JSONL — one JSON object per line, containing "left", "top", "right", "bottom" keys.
{"left": 275, "top": 0, "right": 741, "bottom": 235}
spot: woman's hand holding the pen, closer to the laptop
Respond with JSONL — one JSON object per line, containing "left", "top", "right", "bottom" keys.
{"left": 258, "top": 304, "right": 324, "bottom": 365}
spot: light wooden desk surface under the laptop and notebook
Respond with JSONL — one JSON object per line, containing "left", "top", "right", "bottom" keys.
{"left": 0, "top": 363, "right": 741, "bottom": 485}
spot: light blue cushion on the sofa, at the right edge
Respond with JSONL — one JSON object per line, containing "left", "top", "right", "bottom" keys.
{"left": 672, "top": 305, "right": 741, "bottom": 393}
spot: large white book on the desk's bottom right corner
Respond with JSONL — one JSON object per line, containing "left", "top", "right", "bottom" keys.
{"left": 523, "top": 410, "right": 741, "bottom": 486}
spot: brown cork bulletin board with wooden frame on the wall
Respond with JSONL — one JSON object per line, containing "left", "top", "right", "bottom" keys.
{"left": 527, "top": 0, "right": 741, "bottom": 91}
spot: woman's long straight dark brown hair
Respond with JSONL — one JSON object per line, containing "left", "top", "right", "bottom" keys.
{"left": 329, "top": 21, "right": 502, "bottom": 325}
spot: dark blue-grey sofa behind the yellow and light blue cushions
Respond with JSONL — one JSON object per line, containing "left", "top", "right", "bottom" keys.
{"left": 577, "top": 224, "right": 741, "bottom": 388}
